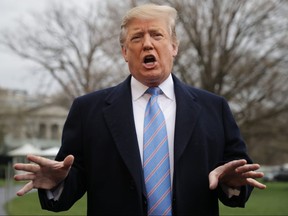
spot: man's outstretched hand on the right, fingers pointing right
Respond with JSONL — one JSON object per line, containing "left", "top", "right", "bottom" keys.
{"left": 209, "top": 159, "right": 266, "bottom": 190}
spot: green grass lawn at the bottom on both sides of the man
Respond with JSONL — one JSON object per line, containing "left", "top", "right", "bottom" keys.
{"left": 5, "top": 183, "right": 288, "bottom": 216}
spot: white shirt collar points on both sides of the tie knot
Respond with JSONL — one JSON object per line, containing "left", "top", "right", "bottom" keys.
{"left": 131, "top": 74, "right": 175, "bottom": 101}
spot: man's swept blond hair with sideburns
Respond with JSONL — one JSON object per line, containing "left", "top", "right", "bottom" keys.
{"left": 119, "top": 4, "right": 178, "bottom": 47}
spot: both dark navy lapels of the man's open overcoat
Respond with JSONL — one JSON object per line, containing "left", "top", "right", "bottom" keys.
{"left": 103, "top": 76, "right": 201, "bottom": 197}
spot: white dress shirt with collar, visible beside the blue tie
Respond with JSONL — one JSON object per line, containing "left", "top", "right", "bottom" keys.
{"left": 131, "top": 74, "right": 176, "bottom": 182}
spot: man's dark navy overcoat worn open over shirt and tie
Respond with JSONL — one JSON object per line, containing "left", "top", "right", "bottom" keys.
{"left": 39, "top": 75, "right": 252, "bottom": 215}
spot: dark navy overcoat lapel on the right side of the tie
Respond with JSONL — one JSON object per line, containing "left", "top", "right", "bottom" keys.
{"left": 173, "top": 76, "right": 201, "bottom": 165}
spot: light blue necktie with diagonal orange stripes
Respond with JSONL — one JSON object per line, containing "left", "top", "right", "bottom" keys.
{"left": 143, "top": 87, "right": 172, "bottom": 215}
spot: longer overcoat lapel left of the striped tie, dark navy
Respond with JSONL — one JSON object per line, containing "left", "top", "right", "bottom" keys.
{"left": 103, "top": 76, "right": 143, "bottom": 194}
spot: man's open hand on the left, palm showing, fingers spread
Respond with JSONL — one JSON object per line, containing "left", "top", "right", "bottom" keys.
{"left": 14, "top": 155, "right": 74, "bottom": 196}
